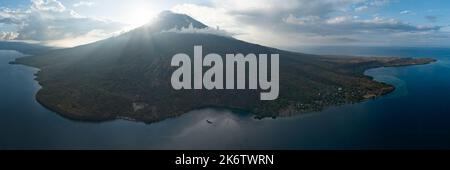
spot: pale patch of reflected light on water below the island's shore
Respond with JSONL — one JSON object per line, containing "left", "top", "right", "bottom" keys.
{"left": 158, "top": 109, "right": 250, "bottom": 149}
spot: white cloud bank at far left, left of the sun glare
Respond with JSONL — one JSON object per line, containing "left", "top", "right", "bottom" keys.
{"left": 0, "top": 0, "right": 122, "bottom": 46}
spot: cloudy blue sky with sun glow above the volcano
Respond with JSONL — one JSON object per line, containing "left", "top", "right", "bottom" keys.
{"left": 0, "top": 0, "right": 450, "bottom": 48}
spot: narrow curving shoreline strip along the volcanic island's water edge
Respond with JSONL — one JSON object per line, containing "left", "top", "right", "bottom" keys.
{"left": 10, "top": 55, "right": 437, "bottom": 124}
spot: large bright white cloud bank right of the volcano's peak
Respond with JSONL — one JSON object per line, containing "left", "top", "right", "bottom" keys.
{"left": 172, "top": 0, "right": 442, "bottom": 47}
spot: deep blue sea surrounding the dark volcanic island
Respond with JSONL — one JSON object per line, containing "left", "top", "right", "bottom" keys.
{"left": 0, "top": 47, "right": 450, "bottom": 149}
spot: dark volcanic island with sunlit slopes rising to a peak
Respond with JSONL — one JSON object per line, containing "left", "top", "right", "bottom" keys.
{"left": 15, "top": 12, "right": 435, "bottom": 123}
